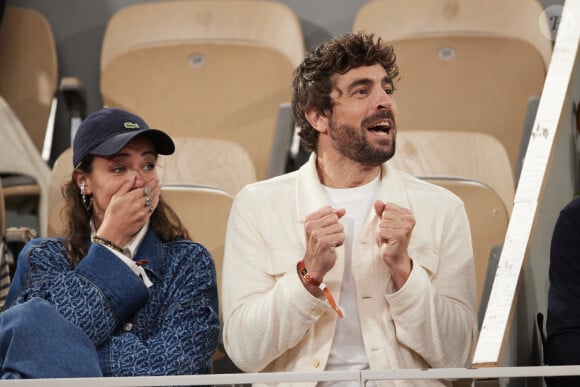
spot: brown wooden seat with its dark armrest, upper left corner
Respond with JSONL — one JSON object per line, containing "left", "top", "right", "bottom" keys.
{"left": 0, "top": 6, "right": 86, "bottom": 165}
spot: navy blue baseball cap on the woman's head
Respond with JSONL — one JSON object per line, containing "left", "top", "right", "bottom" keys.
{"left": 73, "top": 108, "right": 175, "bottom": 168}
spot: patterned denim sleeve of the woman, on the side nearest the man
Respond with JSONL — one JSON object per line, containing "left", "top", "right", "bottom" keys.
{"left": 98, "top": 242, "right": 220, "bottom": 376}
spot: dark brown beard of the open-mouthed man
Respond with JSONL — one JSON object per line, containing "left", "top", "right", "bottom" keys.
{"left": 329, "top": 113, "right": 396, "bottom": 167}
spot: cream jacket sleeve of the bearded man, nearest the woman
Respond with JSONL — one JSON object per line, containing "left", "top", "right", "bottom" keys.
{"left": 222, "top": 190, "right": 330, "bottom": 372}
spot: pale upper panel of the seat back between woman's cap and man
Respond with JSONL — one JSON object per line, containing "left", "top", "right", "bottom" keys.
{"left": 157, "top": 136, "right": 256, "bottom": 195}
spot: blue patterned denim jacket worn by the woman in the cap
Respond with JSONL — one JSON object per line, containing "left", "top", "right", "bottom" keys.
{"left": 0, "top": 229, "right": 220, "bottom": 377}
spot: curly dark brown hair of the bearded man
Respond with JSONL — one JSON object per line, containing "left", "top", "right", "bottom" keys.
{"left": 292, "top": 31, "right": 399, "bottom": 152}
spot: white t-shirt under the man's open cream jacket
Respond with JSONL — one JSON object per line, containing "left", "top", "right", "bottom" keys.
{"left": 319, "top": 175, "right": 380, "bottom": 387}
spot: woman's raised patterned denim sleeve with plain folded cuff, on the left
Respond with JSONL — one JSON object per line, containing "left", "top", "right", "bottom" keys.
{"left": 7, "top": 239, "right": 148, "bottom": 346}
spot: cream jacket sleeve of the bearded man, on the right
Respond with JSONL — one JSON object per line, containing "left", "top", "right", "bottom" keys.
{"left": 385, "top": 205, "right": 477, "bottom": 368}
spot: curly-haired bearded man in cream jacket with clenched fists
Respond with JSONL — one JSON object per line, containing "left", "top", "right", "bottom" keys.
{"left": 222, "top": 33, "right": 477, "bottom": 386}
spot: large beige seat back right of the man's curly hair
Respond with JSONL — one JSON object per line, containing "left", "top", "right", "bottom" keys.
{"left": 353, "top": 0, "right": 552, "bottom": 170}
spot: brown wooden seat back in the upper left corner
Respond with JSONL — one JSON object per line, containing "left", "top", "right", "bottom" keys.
{"left": 0, "top": 6, "right": 58, "bottom": 152}
